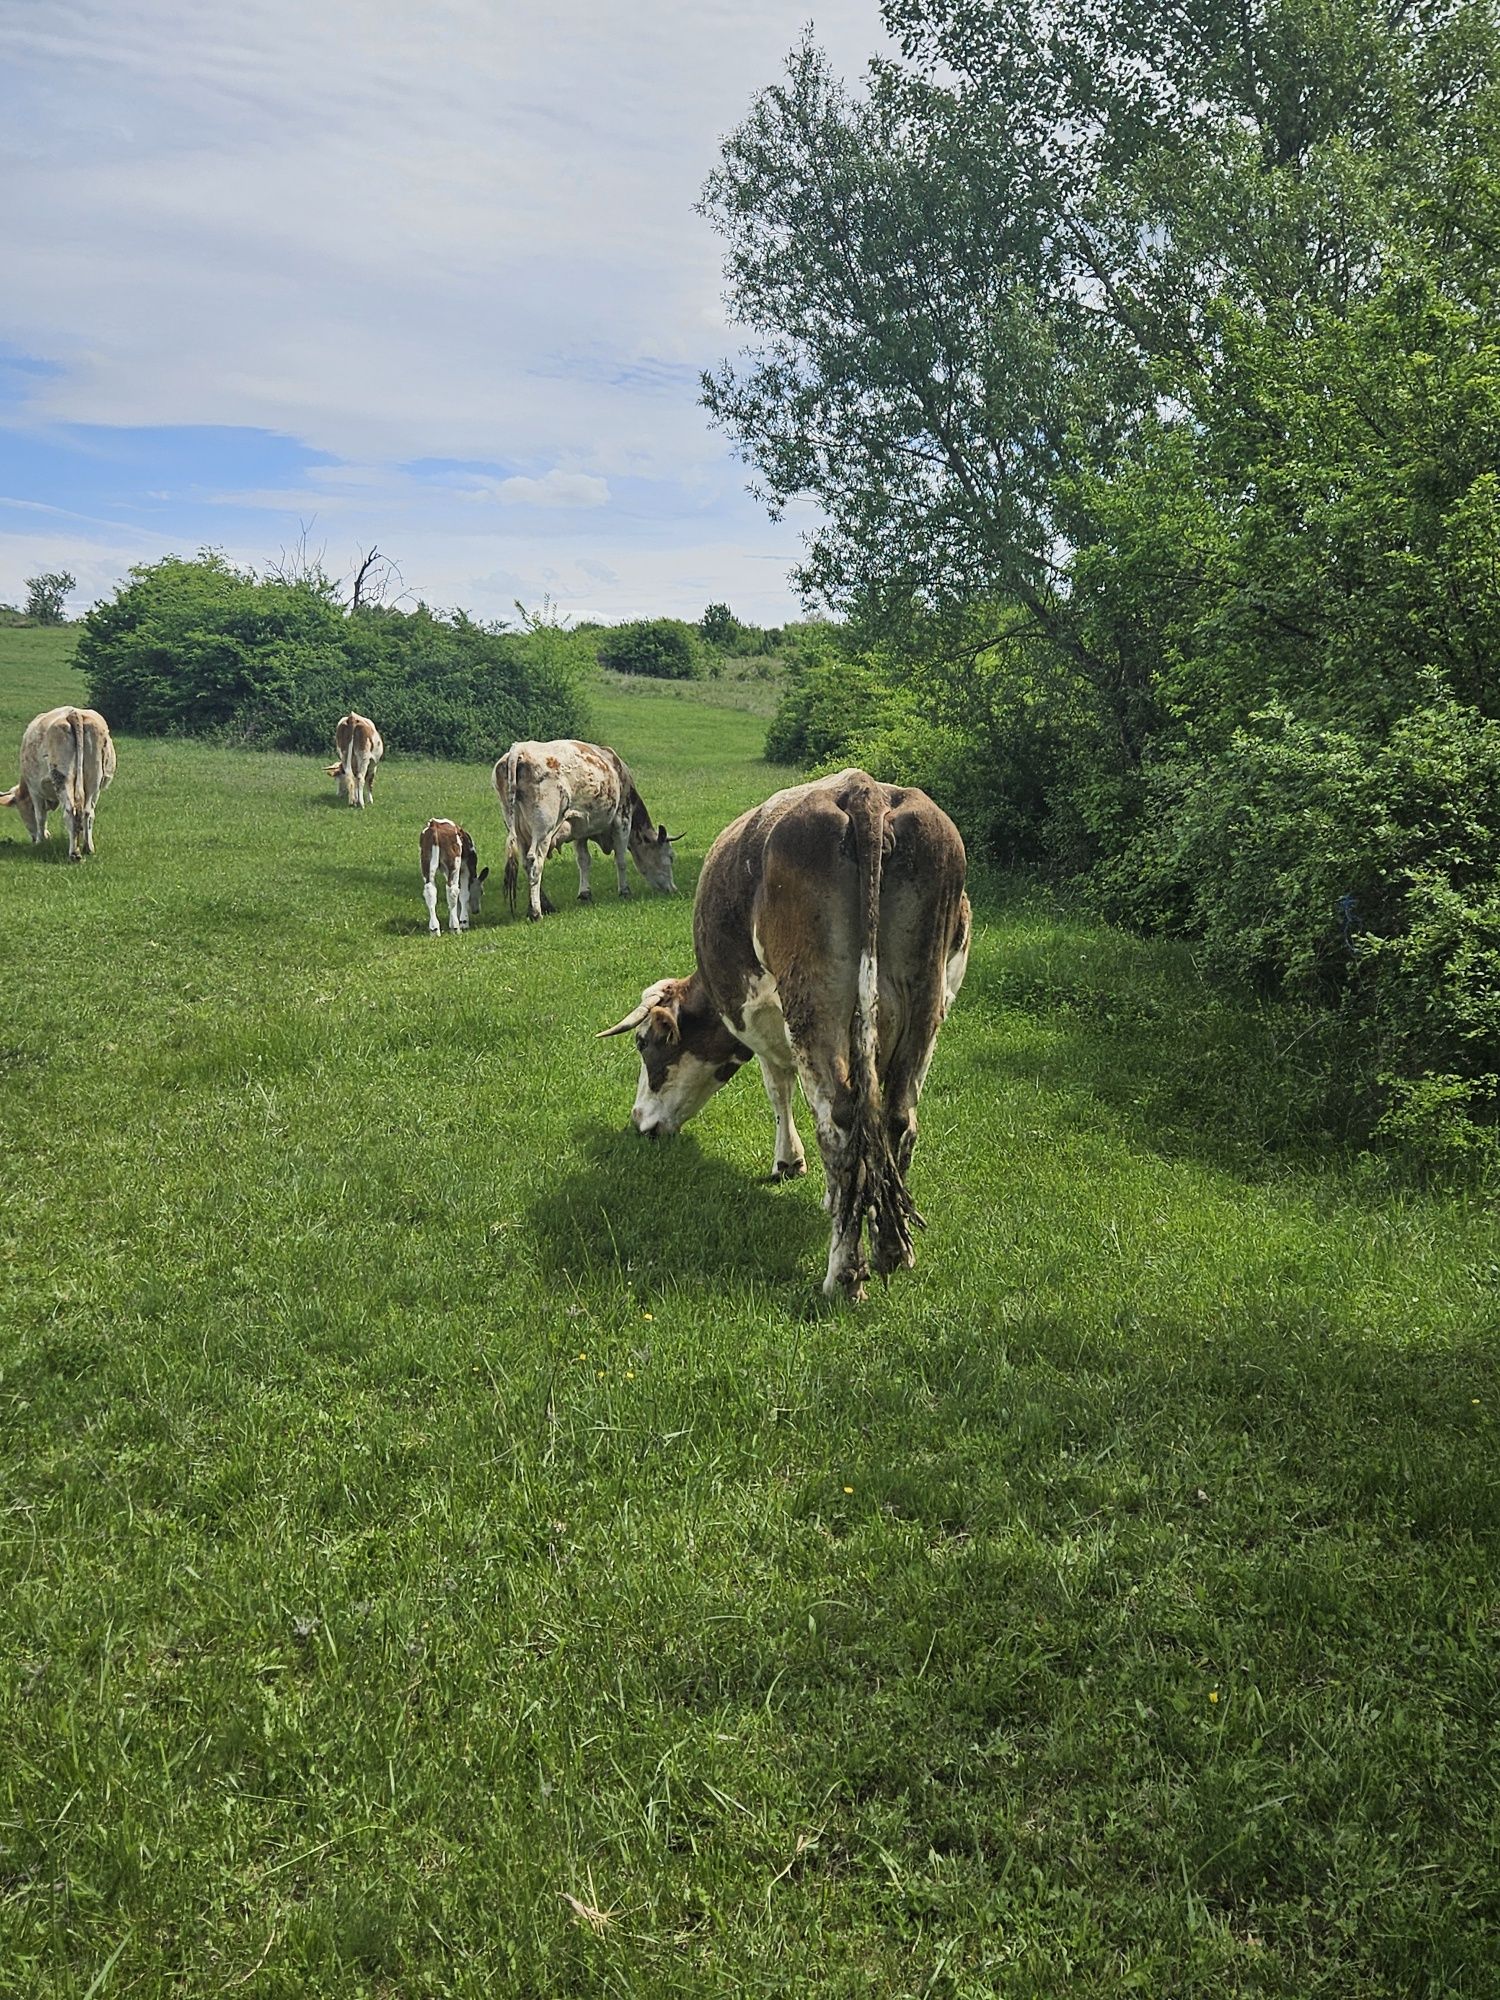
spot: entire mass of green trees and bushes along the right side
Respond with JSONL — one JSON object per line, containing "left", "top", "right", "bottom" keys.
{"left": 704, "top": 0, "right": 1500, "bottom": 1152}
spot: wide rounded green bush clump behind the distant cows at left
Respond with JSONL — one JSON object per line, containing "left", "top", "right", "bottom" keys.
{"left": 78, "top": 552, "right": 586, "bottom": 758}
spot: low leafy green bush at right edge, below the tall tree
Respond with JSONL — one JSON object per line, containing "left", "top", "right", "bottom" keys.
{"left": 1092, "top": 704, "right": 1500, "bottom": 1162}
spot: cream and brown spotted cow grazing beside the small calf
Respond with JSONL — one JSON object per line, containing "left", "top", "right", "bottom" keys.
{"left": 494, "top": 740, "right": 682, "bottom": 922}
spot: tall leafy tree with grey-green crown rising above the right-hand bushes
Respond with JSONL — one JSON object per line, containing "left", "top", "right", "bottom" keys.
{"left": 704, "top": 0, "right": 1500, "bottom": 764}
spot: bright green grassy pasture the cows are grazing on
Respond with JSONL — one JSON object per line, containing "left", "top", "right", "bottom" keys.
{"left": 0, "top": 630, "right": 1500, "bottom": 2000}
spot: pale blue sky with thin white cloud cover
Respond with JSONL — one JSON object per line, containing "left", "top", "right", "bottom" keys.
{"left": 0, "top": 0, "right": 886, "bottom": 624}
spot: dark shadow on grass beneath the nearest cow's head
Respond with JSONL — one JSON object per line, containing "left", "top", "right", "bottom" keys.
{"left": 530, "top": 1126, "right": 828, "bottom": 1290}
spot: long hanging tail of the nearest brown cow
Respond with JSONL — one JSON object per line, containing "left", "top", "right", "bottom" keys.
{"left": 838, "top": 774, "right": 922, "bottom": 1276}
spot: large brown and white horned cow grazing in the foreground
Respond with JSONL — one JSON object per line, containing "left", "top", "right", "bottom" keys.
{"left": 602, "top": 770, "right": 970, "bottom": 1298}
